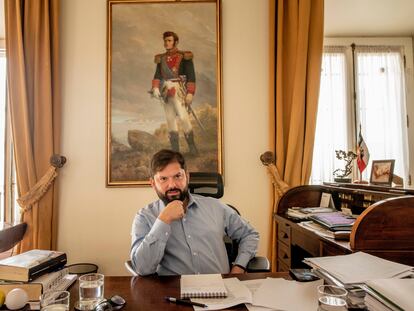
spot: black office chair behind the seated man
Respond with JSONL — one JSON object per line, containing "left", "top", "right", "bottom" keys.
{"left": 188, "top": 172, "right": 270, "bottom": 272}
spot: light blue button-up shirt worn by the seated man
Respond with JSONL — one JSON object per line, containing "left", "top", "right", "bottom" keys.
{"left": 130, "top": 194, "right": 259, "bottom": 275}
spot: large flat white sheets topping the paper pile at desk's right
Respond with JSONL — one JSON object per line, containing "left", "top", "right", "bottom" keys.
{"left": 305, "top": 252, "right": 413, "bottom": 284}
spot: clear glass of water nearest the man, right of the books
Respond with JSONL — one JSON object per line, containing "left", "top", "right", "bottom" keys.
{"left": 79, "top": 273, "right": 104, "bottom": 310}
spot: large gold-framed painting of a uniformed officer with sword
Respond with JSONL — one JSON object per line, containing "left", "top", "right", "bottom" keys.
{"left": 106, "top": 0, "right": 223, "bottom": 187}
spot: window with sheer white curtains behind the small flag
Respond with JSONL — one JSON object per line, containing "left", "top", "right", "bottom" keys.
{"left": 311, "top": 38, "right": 414, "bottom": 184}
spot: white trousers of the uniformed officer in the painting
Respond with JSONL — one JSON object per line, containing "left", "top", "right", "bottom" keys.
{"left": 161, "top": 80, "right": 192, "bottom": 134}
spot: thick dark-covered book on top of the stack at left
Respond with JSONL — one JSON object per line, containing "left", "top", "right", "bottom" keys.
{"left": 0, "top": 249, "right": 67, "bottom": 282}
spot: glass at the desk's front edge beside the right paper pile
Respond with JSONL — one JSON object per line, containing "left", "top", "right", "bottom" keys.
{"left": 318, "top": 285, "right": 348, "bottom": 311}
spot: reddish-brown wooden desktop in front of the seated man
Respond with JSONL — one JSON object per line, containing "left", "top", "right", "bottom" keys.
{"left": 70, "top": 273, "right": 289, "bottom": 311}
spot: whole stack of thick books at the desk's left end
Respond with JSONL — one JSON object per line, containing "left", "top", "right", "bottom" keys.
{"left": 0, "top": 249, "right": 76, "bottom": 310}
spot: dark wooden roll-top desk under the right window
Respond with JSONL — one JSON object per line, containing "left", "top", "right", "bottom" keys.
{"left": 274, "top": 184, "right": 414, "bottom": 271}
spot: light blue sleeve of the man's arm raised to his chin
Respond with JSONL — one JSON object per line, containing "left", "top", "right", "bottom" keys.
{"left": 130, "top": 213, "right": 171, "bottom": 275}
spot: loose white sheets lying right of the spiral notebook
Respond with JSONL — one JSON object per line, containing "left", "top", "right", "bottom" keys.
{"left": 191, "top": 278, "right": 323, "bottom": 311}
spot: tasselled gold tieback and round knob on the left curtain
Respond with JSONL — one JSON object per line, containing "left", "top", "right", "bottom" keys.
{"left": 17, "top": 154, "right": 66, "bottom": 215}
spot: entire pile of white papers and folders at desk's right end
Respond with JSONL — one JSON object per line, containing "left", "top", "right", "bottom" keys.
{"left": 304, "top": 252, "right": 414, "bottom": 311}
